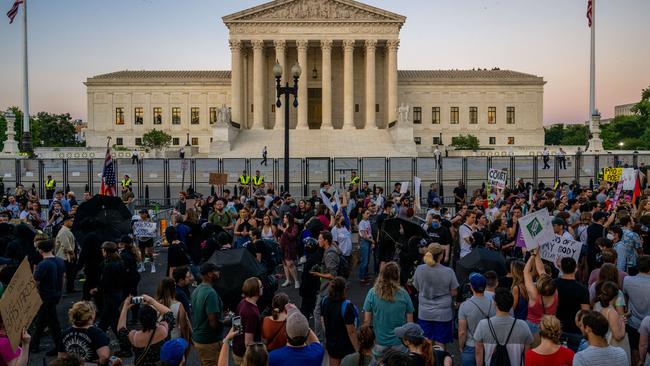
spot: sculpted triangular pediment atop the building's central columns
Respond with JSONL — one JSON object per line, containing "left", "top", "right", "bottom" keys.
{"left": 223, "top": 0, "right": 406, "bottom": 25}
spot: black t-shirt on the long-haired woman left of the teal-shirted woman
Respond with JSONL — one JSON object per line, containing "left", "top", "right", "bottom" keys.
{"left": 321, "top": 298, "right": 355, "bottom": 359}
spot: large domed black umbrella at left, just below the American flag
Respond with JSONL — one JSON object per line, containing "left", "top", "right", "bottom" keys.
{"left": 72, "top": 195, "right": 131, "bottom": 243}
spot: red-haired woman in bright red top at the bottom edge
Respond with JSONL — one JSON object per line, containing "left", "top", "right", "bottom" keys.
{"left": 525, "top": 315, "right": 573, "bottom": 366}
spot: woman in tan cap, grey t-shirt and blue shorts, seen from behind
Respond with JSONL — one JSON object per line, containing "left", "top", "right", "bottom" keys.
{"left": 413, "top": 243, "right": 458, "bottom": 347}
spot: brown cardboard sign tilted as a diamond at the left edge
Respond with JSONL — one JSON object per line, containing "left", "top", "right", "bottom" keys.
{"left": 0, "top": 259, "right": 43, "bottom": 352}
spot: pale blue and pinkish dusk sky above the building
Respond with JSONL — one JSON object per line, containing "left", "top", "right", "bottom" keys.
{"left": 0, "top": 0, "right": 650, "bottom": 124}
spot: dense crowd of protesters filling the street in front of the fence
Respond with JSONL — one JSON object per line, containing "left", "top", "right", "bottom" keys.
{"left": 0, "top": 163, "right": 650, "bottom": 366}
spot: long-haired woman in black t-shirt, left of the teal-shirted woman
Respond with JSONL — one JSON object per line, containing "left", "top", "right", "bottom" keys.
{"left": 321, "top": 277, "right": 359, "bottom": 366}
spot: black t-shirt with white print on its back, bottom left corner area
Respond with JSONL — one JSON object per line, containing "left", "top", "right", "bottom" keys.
{"left": 59, "top": 326, "right": 109, "bottom": 362}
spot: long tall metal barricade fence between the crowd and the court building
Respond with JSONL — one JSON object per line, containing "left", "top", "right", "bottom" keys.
{"left": 0, "top": 152, "right": 650, "bottom": 207}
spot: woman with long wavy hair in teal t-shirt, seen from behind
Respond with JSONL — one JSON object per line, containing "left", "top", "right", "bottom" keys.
{"left": 363, "top": 262, "right": 414, "bottom": 358}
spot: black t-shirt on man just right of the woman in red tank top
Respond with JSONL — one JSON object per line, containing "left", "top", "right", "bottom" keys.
{"left": 555, "top": 278, "right": 589, "bottom": 334}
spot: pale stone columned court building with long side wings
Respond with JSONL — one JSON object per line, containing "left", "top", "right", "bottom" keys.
{"left": 85, "top": 0, "right": 545, "bottom": 157}
